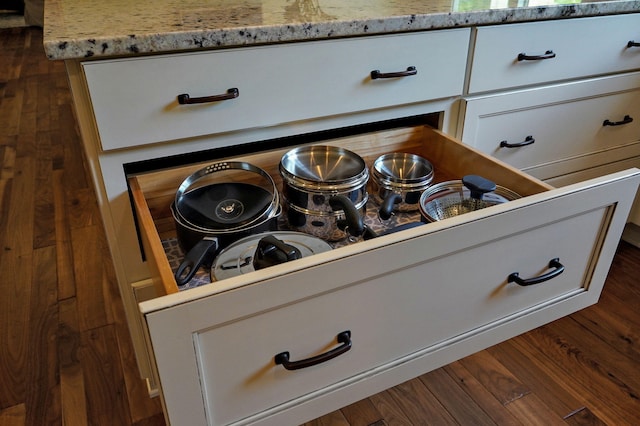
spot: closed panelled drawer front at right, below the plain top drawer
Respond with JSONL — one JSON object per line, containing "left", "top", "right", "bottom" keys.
{"left": 462, "top": 73, "right": 640, "bottom": 179}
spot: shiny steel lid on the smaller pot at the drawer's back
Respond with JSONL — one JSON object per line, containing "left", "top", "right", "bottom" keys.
{"left": 371, "top": 152, "right": 433, "bottom": 186}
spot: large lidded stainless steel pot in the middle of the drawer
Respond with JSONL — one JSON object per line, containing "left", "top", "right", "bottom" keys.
{"left": 279, "top": 145, "right": 369, "bottom": 241}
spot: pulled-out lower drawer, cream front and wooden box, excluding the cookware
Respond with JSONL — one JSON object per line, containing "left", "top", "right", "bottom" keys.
{"left": 129, "top": 127, "right": 640, "bottom": 425}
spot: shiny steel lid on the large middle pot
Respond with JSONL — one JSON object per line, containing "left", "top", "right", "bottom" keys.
{"left": 280, "top": 145, "right": 369, "bottom": 189}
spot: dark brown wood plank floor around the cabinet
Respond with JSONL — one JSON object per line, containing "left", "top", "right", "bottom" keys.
{"left": 0, "top": 28, "right": 640, "bottom": 426}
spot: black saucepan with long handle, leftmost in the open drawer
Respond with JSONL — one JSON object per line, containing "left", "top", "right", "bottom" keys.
{"left": 171, "top": 162, "right": 282, "bottom": 285}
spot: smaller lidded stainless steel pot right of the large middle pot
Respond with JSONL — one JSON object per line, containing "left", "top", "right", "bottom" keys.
{"left": 371, "top": 152, "right": 434, "bottom": 220}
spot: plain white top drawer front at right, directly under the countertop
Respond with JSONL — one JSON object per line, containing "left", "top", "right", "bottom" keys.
{"left": 469, "top": 14, "right": 640, "bottom": 93}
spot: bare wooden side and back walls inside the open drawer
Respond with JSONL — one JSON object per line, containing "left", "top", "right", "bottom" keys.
{"left": 128, "top": 126, "right": 552, "bottom": 296}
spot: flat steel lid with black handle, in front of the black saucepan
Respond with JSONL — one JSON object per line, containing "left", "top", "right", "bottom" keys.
{"left": 211, "top": 231, "right": 332, "bottom": 281}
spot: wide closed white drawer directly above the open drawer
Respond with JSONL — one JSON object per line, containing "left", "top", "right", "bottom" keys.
{"left": 83, "top": 29, "right": 470, "bottom": 150}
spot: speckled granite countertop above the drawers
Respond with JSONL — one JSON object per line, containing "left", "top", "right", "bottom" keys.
{"left": 44, "top": 0, "right": 640, "bottom": 60}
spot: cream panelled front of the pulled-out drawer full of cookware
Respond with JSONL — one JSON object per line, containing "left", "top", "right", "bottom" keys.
{"left": 143, "top": 169, "right": 639, "bottom": 424}
